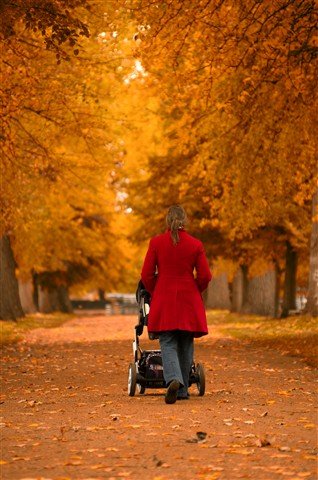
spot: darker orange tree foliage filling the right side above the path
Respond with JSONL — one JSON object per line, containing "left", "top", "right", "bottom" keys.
{"left": 118, "top": 1, "right": 317, "bottom": 311}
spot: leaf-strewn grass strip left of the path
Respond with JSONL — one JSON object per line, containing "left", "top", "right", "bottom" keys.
{"left": 0, "top": 312, "right": 72, "bottom": 345}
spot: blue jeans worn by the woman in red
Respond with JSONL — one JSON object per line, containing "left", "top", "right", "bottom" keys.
{"left": 159, "top": 330, "right": 194, "bottom": 397}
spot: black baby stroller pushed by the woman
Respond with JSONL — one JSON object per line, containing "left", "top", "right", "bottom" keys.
{"left": 128, "top": 281, "right": 205, "bottom": 397}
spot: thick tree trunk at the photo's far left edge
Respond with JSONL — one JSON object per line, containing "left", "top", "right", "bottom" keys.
{"left": 0, "top": 235, "right": 24, "bottom": 320}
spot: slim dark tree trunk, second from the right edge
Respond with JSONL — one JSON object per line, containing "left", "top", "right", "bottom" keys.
{"left": 281, "top": 240, "right": 297, "bottom": 318}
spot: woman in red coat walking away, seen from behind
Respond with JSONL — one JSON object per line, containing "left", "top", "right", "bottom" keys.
{"left": 141, "top": 205, "right": 212, "bottom": 403}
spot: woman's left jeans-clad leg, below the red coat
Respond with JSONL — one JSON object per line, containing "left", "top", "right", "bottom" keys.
{"left": 159, "top": 332, "right": 183, "bottom": 385}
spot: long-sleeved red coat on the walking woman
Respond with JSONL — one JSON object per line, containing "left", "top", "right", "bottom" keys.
{"left": 141, "top": 230, "right": 212, "bottom": 337}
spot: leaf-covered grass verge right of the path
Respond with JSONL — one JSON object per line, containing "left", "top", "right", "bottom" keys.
{"left": 208, "top": 310, "right": 318, "bottom": 366}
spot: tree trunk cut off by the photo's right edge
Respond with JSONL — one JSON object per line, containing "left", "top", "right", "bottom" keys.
{"left": 306, "top": 190, "right": 318, "bottom": 317}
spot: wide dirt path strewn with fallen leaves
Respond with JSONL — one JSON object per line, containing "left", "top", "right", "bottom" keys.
{"left": 0, "top": 317, "right": 317, "bottom": 480}
